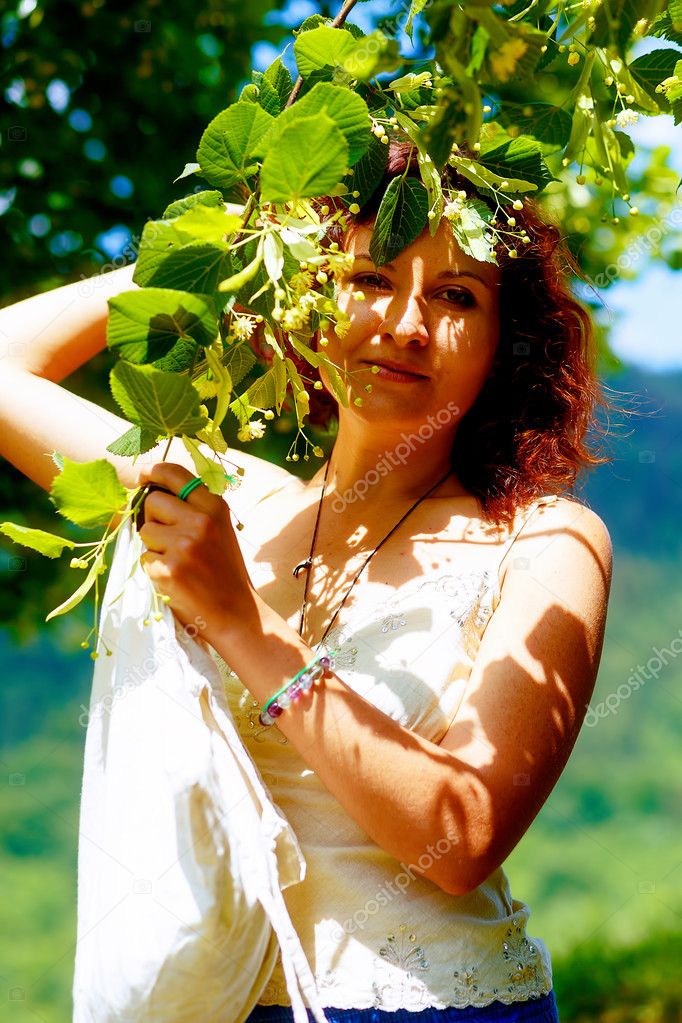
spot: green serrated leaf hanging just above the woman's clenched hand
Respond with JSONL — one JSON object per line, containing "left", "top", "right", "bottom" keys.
{"left": 109, "top": 362, "right": 206, "bottom": 437}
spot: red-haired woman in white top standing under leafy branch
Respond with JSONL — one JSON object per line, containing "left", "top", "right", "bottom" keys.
{"left": 0, "top": 146, "right": 611, "bottom": 1023}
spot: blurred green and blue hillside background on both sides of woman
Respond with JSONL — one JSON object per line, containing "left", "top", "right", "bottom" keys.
{"left": 0, "top": 370, "right": 682, "bottom": 1023}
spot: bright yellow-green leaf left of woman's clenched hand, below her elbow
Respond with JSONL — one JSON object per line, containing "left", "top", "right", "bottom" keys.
{"left": 50, "top": 460, "right": 128, "bottom": 527}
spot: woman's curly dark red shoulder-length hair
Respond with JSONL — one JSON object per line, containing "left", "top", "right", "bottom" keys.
{"left": 276, "top": 139, "right": 615, "bottom": 526}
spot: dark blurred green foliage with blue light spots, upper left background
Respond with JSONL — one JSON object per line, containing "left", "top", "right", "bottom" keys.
{"left": 0, "top": 0, "right": 284, "bottom": 296}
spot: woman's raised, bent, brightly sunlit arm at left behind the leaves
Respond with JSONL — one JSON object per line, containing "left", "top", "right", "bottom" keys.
{"left": 0, "top": 264, "right": 290, "bottom": 508}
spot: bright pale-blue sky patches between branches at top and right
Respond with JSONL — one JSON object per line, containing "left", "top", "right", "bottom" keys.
{"left": 252, "top": 7, "right": 682, "bottom": 372}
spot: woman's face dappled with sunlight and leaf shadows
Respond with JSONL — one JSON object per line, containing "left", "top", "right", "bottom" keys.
{"left": 321, "top": 220, "right": 500, "bottom": 430}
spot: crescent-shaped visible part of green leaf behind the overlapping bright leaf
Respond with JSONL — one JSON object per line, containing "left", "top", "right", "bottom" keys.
{"left": 266, "top": 82, "right": 372, "bottom": 165}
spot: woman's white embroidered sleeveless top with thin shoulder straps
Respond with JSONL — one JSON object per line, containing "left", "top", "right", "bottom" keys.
{"left": 213, "top": 495, "right": 556, "bottom": 1012}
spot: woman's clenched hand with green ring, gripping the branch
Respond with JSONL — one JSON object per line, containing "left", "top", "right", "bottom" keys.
{"left": 134, "top": 461, "right": 255, "bottom": 642}
